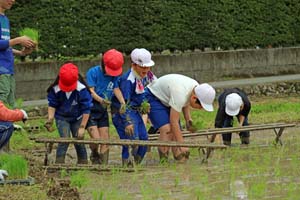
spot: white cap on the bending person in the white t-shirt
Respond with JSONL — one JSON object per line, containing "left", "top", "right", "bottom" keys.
{"left": 195, "top": 83, "right": 216, "bottom": 112}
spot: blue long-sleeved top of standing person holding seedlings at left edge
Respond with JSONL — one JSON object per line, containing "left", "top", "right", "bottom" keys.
{"left": 0, "top": 15, "right": 14, "bottom": 74}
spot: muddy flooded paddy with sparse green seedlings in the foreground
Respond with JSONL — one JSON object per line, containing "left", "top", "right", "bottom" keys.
{"left": 71, "top": 127, "right": 300, "bottom": 200}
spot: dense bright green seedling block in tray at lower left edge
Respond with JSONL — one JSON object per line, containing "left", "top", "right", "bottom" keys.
{"left": 0, "top": 154, "right": 28, "bottom": 179}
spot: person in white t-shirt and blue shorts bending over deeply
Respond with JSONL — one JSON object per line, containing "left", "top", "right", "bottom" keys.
{"left": 146, "top": 74, "right": 216, "bottom": 161}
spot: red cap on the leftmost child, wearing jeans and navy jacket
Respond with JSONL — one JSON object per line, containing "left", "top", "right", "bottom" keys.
{"left": 58, "top": 63, "right": 78, "bottom": 92}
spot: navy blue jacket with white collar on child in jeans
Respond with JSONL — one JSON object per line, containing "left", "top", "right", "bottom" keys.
{"left": 47, "top": 81, "right": 92, "bottom": 122}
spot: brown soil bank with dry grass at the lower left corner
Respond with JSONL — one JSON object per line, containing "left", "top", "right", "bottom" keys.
{"left": 0, "top": 146, "right": 80, "bottom": 200}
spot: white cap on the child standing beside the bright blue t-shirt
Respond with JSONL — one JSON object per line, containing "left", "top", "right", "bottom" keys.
{"left": 130, "top": 48, "right": 155, "bottom": 67}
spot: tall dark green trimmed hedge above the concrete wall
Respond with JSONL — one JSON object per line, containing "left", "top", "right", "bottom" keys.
{"left": 7, "top": 0, "right": 300, "bottom": 58}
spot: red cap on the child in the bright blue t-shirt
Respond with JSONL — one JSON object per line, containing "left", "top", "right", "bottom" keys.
{"left": 103, "top": 49, "right": 124, "bottom": 76}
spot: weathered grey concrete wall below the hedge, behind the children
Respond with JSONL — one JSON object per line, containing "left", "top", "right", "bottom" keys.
{"left": 15, "top": 47, "right": 300, "bottom": 100}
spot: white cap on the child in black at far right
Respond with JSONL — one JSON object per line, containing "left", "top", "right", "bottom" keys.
{"left": 225, "top": 93, "right": 243, "bottom": 116}
